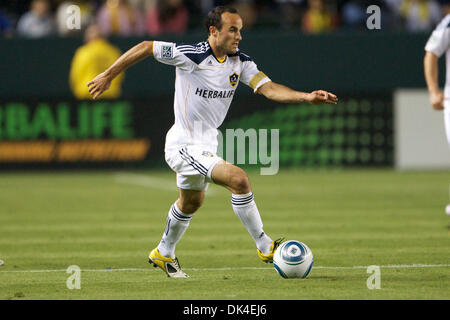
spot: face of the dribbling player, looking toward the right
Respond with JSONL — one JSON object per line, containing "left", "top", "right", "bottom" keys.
{"left": 217, "top": 12, "right": 243, "bottom": 54}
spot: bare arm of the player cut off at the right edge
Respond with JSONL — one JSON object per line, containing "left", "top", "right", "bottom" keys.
{"left": 423, "top": 51, "right": 444, "bottom": 110}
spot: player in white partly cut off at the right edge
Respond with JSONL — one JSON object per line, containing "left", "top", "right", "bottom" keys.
{"left": 423, "top": 1, "right": 450, "bottom": 214}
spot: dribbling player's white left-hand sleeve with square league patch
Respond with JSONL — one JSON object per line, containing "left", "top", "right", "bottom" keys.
{"left": 153, "top": 41, "right": 193, "bottom": 71}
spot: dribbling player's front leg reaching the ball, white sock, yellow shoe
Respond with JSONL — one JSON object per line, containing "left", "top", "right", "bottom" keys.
{"left": 211, "top": 161, "right": 281, "bottom": 262}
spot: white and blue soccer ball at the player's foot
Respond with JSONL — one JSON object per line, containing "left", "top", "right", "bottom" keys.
{"left": 273, "top": 240, "right": 314, "bottom": 278}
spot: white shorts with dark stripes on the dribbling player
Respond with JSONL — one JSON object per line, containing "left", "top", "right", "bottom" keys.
{"left": 165, "top": 145, "right": 223, "bottom": 191}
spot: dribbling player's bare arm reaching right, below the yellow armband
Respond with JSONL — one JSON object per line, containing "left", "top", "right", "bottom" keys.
{"left": 256, "top": 81, "right": 338, "bottom": 104}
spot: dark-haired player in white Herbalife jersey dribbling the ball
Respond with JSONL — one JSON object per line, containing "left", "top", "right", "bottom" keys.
{"left": 88, "top": 6, "right": 338, "bottom": 278}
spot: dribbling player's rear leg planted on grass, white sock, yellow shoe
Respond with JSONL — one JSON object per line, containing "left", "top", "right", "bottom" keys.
{"left": 149, "top": 189, "right": 205, "bottom": 278}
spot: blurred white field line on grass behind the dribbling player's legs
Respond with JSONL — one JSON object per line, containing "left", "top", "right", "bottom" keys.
{"left": 115, "top": 172, "right": 215, "bottom": 195}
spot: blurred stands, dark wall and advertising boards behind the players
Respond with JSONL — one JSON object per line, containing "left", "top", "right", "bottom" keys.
{"left": 0, "top": 0, "right": 450, "bottom": 170}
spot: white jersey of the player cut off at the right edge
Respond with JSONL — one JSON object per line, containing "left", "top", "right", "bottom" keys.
{"left": 425, "top": 14, "right": 450, "bottom": 98}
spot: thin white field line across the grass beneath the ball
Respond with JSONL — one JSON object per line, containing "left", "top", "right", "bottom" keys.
{"left": 0, "top": 264, "right": 450, "bottom": 273}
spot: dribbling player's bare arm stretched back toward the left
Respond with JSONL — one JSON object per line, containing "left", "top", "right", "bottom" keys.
{"left": 87, "top": 41, "right": 153, "bottom": 99}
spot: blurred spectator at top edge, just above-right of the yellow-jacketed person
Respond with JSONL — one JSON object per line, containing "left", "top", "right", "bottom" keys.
{"left": 97, "top": 0, "right": 145, "bottom": 36}
